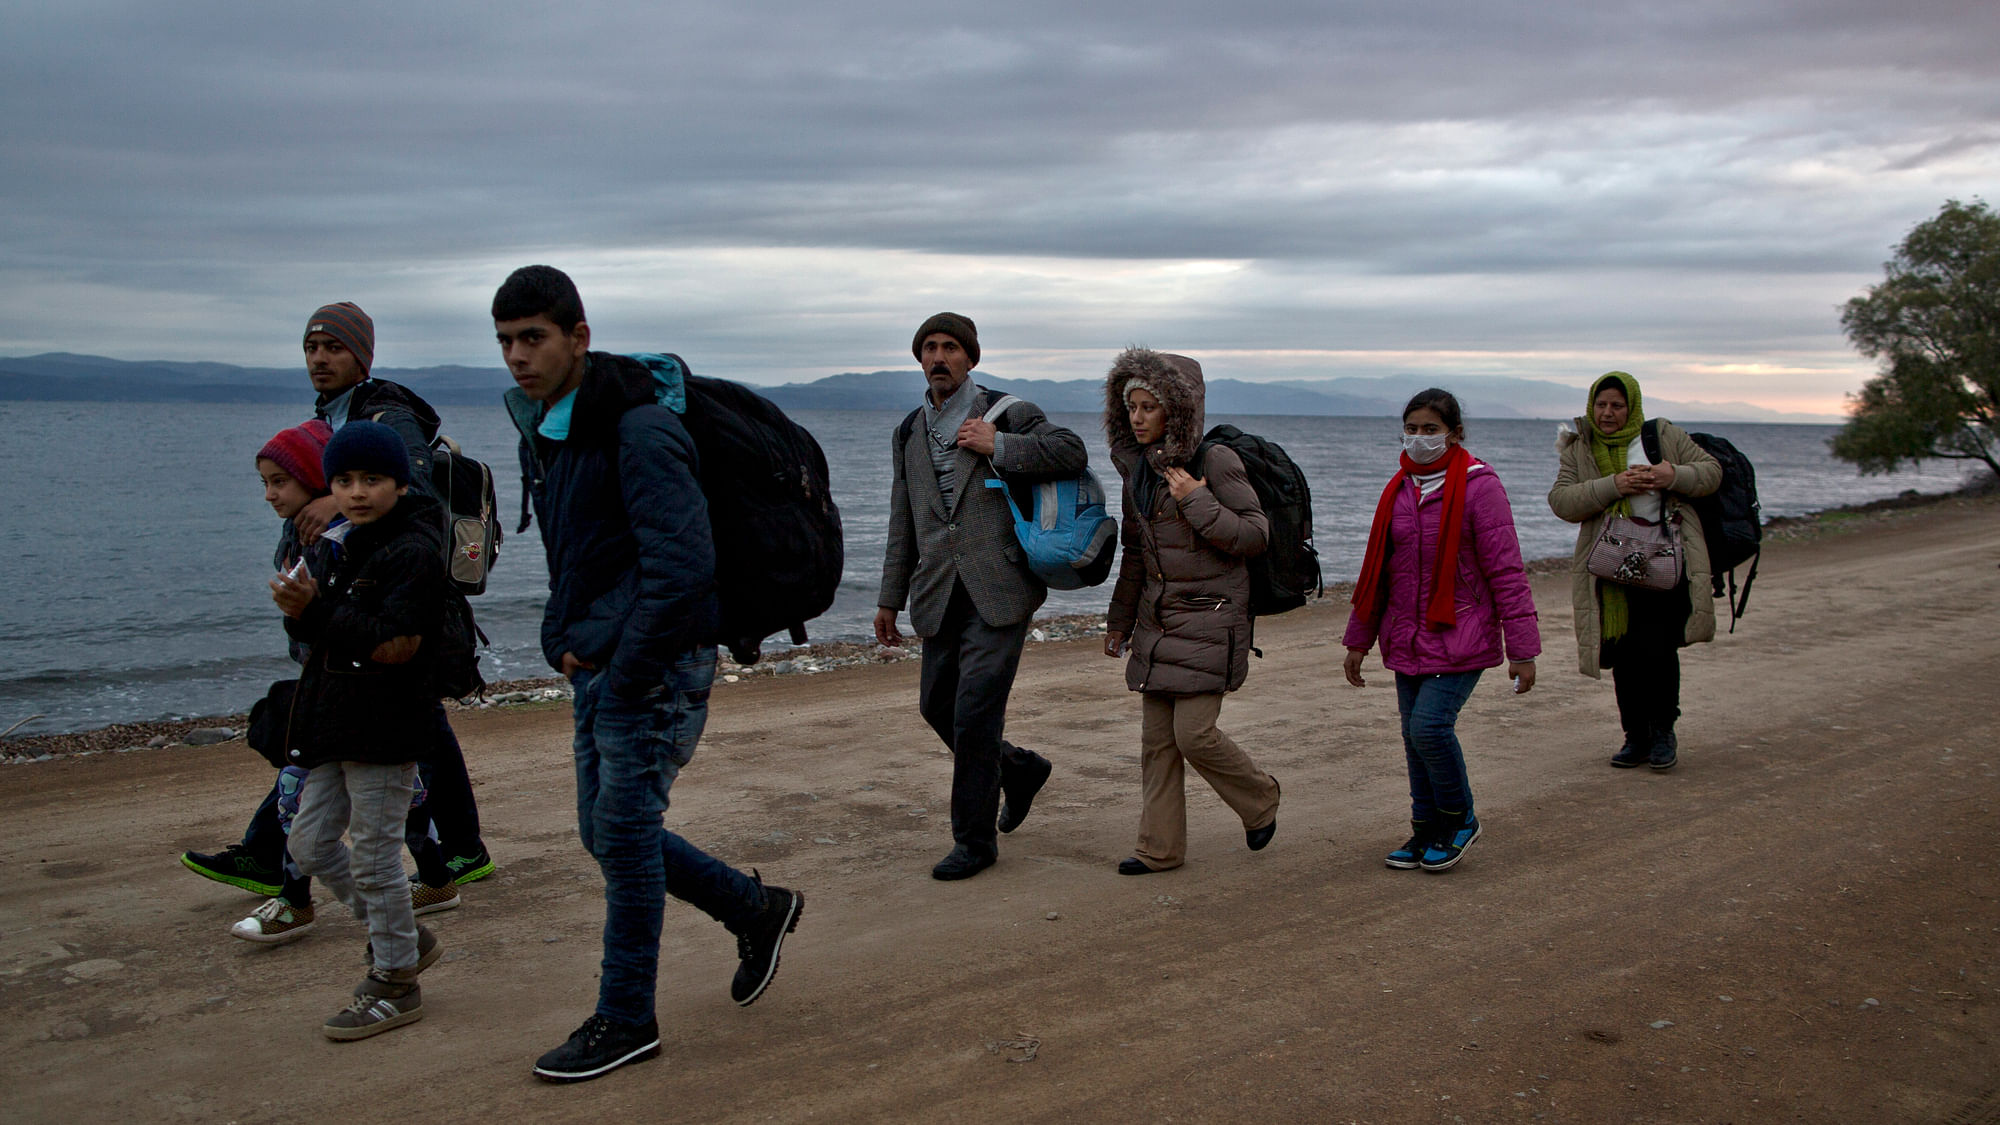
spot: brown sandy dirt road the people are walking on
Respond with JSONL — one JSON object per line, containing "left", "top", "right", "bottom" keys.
{"left": 0, "top": 500, "right": 2000, "bottom": 1125}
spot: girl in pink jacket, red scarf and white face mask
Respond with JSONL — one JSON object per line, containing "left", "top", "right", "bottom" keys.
{"left": 1344, "top": 388, "right": 1542, "bottom": 871}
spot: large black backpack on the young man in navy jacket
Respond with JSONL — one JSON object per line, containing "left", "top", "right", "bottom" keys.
{"left": 660, "top": 354, "right": 846, "bottom": 665}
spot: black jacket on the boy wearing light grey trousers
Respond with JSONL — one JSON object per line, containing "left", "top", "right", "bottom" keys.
{"left": 284, "top": 488, "right": 446, "bottom": 769}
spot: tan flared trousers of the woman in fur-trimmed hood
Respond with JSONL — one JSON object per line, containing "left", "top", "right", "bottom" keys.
{"left": 1132, "top": 691, "right": 1278, "bottom": 871}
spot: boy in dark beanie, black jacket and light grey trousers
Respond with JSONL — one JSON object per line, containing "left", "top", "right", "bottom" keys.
{"left": 272, "top": 420, "right": 446, "bottom": 1039}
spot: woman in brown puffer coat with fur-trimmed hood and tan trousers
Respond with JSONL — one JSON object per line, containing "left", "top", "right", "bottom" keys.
{"left": 1104, "top": 348, "right": 1278, "bottom": 875}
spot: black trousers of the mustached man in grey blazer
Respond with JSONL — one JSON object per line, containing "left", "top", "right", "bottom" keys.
{"left": 918, "top": 585, "right": 1040, "bottom": 857}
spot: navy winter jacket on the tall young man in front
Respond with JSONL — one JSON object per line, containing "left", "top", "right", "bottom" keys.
{"left": 506, "top": 352, "right": 722, "bottom": 699}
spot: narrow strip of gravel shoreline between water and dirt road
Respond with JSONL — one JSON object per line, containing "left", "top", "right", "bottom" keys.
{"left": 11, "top": 480, "right": 2000, "bottom": 765}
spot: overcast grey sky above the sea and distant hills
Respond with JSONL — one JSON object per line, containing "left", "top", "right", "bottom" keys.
{"left": 0, "top": 0, "right": 2000, "bottom": 412}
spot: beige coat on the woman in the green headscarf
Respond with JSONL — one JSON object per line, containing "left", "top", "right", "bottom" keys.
{"left": 1548, "top": 418, "right": 1722, "bottom": 677}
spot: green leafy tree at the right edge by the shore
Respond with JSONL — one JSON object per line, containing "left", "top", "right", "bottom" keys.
{"left": 1832, "top": 200, "right": 2000, "bottom": 474}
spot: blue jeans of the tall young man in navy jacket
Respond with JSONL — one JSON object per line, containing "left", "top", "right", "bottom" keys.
{"left": 572, "top": 645, "right": 764, "bottom": 1023}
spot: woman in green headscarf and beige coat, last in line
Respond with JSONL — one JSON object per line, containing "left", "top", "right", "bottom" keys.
{"left": 1548, "top": 370, "right": 1722, "bottom": 769}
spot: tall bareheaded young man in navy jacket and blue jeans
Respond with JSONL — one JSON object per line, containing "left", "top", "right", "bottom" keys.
{"left": 492, "top": 266, "right": 806, "bottom": 1081}
